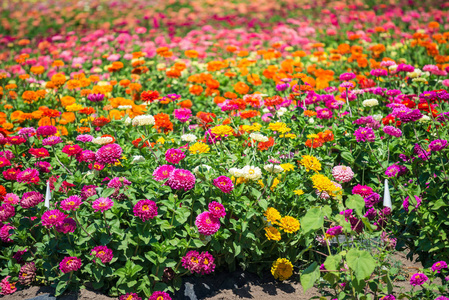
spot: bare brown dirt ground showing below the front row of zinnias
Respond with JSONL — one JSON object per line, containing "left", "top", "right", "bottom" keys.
{"left": 1, "top": 253, "right": 422, "bottom": 300}
